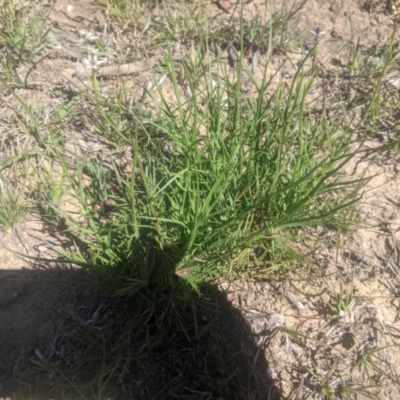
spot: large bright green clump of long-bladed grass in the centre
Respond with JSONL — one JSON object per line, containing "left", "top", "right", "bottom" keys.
{"left": 47, "top": 55, "right": 366, "bottom": 293}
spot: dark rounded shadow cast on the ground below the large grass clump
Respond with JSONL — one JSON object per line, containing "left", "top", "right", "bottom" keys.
{"left": 0, "top": 268, "right": 281, "bottom": 399}
